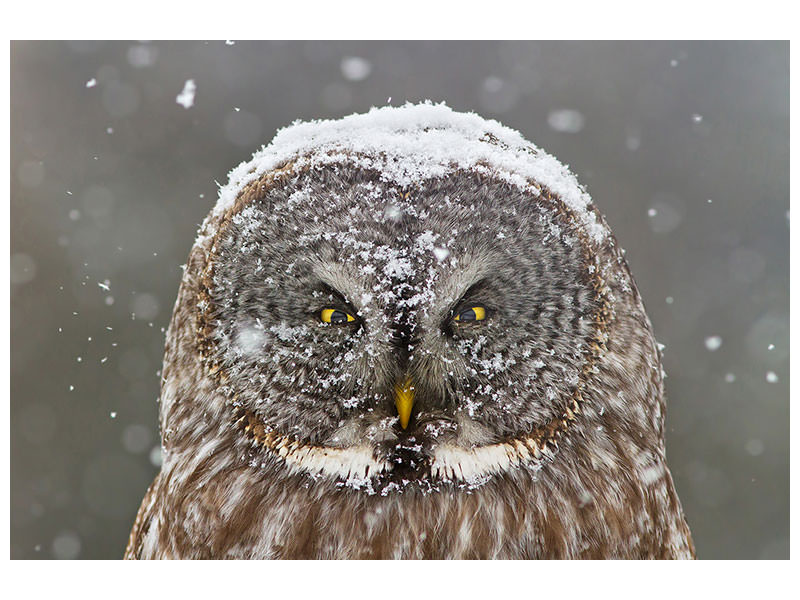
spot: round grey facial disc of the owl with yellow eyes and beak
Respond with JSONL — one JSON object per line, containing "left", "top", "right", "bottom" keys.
{"left": 199, "top": 164, "right": 603, "bottom": 492}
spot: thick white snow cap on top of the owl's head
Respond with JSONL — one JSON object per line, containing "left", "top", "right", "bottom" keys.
{"left": 203, "top": 101, "right": 607, "bottom": 243}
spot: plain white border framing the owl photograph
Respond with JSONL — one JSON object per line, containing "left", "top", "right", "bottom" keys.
{"left": 2, "top": 0, "right": 800, "bottom": 600}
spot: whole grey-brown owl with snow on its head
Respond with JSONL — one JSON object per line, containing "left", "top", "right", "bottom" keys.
{"left": 125, "top": 102, "right": 694, "bottom": 559}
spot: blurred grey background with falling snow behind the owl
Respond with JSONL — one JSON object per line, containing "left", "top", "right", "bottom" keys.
{"left": 10, "top": 41, "right": 789, "bottom": 558}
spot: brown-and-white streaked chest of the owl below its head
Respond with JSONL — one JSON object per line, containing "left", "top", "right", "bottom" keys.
{"left": 152, "top": 438, "right": 686, "bottom": 559}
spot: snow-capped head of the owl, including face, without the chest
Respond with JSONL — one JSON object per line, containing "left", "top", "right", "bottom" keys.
{"left": 161, "top": 103, "right": 662, "bottom": 495}
